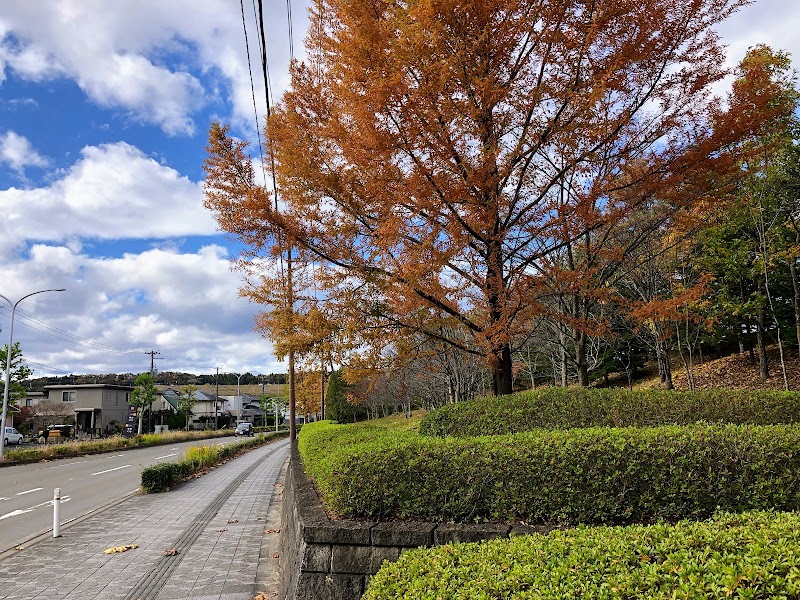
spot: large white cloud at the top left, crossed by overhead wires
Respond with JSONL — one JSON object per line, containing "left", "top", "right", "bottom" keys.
{"left": 0, "top": 0, "right": 306, "bottom": 135}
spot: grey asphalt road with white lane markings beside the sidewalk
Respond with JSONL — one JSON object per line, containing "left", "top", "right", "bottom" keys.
{"left": 0, "top": 436, "right": 244, "bottom": 553}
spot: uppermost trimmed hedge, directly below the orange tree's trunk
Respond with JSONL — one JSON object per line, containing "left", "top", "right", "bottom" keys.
{"left": 420, "top": 388, "right": 800, "bottom": 437}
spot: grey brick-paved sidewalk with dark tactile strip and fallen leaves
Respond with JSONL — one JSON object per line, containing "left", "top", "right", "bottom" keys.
{"left": 0, "top": 440, "right": 289, "bottom": 600}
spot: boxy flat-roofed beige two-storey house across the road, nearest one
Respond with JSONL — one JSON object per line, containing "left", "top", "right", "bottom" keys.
{"left": 44, "top": 383, "right": 134, "bottom": 435}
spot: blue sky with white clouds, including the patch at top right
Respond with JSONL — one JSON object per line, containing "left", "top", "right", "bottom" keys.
{"left": 0, "top": 0, "right": 800, "bottom": 377}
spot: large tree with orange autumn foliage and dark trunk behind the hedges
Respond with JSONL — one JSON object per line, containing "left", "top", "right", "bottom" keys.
{"left": 207, "top": 0, "right": 788, "bottom": 393}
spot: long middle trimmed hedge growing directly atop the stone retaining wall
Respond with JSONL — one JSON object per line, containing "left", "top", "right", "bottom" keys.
{"left": 299, "top": 422, "right": 800, "bottom": 524}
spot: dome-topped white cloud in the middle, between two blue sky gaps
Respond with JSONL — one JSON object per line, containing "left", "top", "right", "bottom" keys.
{"left": 0, "top": 142, "right": 217, "bottom": 256}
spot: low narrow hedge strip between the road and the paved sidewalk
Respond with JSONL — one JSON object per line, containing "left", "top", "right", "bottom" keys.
{"left": 141, "top": 432, "right": 286, "bottom": 494}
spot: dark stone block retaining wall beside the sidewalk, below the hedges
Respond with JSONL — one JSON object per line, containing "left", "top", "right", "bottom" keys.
{"left": 280, "top": 445, "right": 541, "bottom": 600}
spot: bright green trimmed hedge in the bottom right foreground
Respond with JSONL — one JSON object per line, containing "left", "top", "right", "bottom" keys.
{"left": 363, "top": 512, "right": 800, "bottom": 600}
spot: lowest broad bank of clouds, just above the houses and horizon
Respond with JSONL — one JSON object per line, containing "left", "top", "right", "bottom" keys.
{"left": 0, "top": 244, "right": 283, "bottom": 373}
